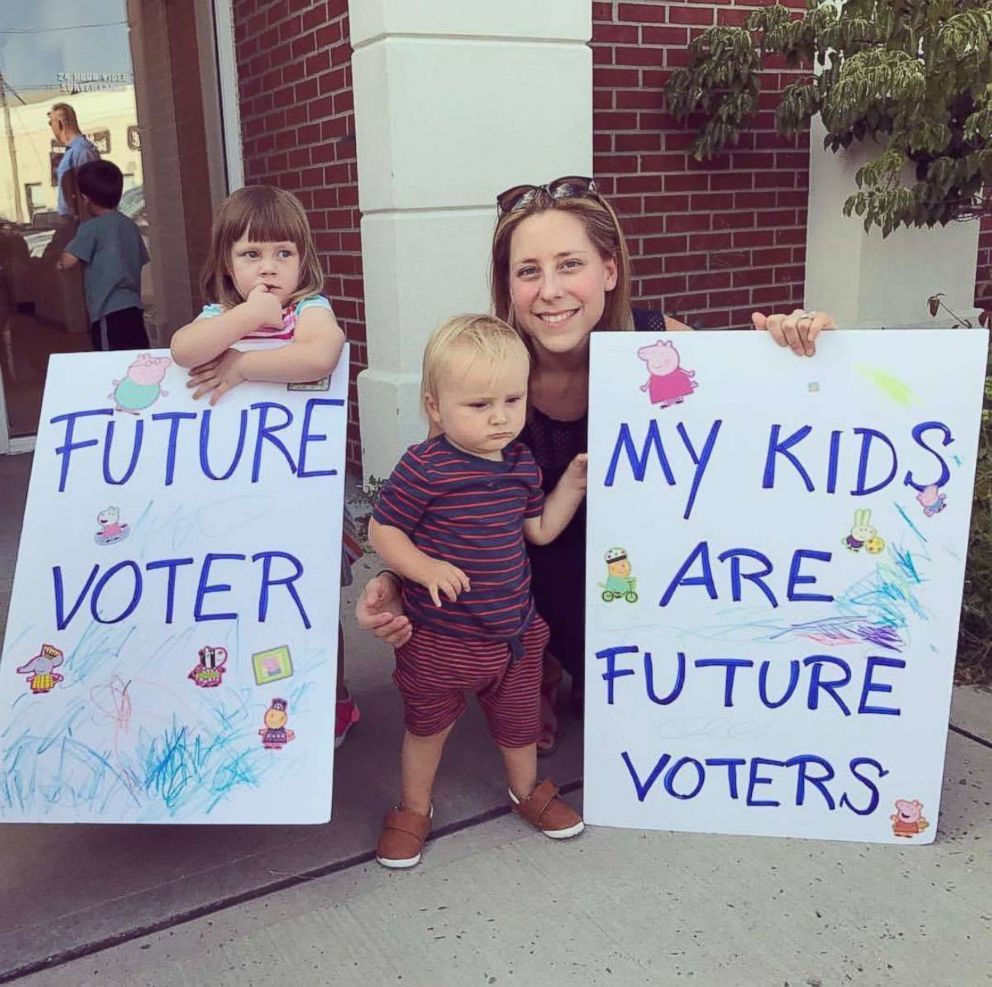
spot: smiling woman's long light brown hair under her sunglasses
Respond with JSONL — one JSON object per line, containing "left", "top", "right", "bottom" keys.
{"left": 490, "top": 190, "right": 634, "bottom": 338}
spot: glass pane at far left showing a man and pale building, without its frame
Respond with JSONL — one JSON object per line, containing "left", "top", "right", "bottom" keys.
{"left": 0, "top": 0, "right": 154, "bottom": 445}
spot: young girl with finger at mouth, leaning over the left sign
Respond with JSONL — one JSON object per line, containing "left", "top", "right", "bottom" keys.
{"left": 172, "top": 185, "right": 362, "bottom": 747}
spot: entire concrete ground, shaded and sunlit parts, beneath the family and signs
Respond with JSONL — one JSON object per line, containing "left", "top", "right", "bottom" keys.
{"left": 0, "top": 457, "right": 992, "bottom": 987}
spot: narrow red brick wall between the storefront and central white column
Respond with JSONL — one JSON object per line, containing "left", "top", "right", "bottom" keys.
{"left": 234, "top": 0, "right": 368, "bottom": 467}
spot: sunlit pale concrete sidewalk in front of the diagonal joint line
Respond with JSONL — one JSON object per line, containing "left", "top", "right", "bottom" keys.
{"left": 13, "top": 691, "right": 992, "bottom": 987}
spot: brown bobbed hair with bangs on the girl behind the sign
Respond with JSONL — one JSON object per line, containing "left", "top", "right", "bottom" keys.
{"left": 200, "top": 185, "right": 324, "bottom": 308}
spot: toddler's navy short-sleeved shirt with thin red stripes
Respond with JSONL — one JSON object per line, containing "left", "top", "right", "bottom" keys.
{"left": 372, "top": 435, "right": 544, "bottom": 641}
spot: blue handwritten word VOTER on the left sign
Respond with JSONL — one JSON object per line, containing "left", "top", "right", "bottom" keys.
{"left": 52, "top": 551, "right": 310, "bottom": 631}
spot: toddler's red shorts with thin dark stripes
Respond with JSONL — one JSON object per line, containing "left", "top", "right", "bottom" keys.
{"left": 393, "top": 614, "right": 549, "bottom": 747}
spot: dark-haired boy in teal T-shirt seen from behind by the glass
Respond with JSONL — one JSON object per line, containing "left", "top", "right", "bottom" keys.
{"left": 58, "top": 161, "right": 148, "bottom": 350}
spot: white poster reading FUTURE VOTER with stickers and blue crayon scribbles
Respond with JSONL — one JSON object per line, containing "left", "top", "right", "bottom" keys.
{"left": 0, "top": 351, "right": 348, "bottom": 823}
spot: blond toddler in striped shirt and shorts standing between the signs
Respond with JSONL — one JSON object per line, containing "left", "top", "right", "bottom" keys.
{"left": 370, "top": 315, "right": 586, "bottom": 867}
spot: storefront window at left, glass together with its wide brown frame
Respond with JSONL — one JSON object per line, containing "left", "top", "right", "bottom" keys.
{"left": 0, "top": 0, "right": 229, "bottom": 452}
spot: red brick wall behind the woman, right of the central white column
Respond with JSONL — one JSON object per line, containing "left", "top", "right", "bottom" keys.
{"left": 592, "top": 0, "right": 809, "bottom": 329}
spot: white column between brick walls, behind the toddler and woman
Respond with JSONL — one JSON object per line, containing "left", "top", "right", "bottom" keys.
{"left": 349, "top": 0, "right": 592, "bottom": 480}
